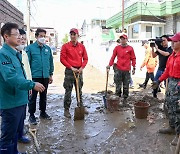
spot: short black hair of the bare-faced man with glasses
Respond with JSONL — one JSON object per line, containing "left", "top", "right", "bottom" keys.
{"left": 1, "top": 22, "right": 19, "bottom": 40}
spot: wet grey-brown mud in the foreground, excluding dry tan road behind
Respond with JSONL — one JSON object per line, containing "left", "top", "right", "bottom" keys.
{"left": 19, "top": 94, "right": 177, "bottom": 154}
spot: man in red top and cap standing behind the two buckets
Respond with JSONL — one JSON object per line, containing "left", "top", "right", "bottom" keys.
{"left": 106, "top": 34, "right": 136, "bottom": 106}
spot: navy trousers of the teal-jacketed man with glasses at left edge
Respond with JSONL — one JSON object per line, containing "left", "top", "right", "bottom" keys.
{"left": 0, "top": 105, "right": 26, "bottom": 154}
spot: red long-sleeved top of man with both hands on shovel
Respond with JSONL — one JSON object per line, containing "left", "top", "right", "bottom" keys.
{"left": 60, "top": 42, "right": 88, "bottom": 68}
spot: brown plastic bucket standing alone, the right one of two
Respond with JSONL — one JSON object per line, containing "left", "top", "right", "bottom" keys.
{"left": 134, "top": 102, "right": 150, "bottom": 119}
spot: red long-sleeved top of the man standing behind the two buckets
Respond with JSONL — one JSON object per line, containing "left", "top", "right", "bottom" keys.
{"left": 109, "top": 45, "right": 136, "bottom": 71}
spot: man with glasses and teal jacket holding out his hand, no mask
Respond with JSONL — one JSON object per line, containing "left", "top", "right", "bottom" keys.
{"left": 0, "top": 23, "right": 45, "bottom": 154}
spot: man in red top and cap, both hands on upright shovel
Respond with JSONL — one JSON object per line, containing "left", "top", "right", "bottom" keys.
{"left": 60, "top": 28, "right": 88, "bottom": 118}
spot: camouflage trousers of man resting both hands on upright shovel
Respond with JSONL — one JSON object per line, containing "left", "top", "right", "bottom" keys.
{"left": 63, "top": 68, "right": 83, "bottom": 109}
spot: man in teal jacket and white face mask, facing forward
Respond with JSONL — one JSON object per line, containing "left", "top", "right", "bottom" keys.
{"left": 26, "top": 28, "right": 54, "bottom": 125}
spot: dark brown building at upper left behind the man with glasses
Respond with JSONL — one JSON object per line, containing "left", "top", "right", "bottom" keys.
{"left": 0, "top": 0, "right": 24, "bottom": 44}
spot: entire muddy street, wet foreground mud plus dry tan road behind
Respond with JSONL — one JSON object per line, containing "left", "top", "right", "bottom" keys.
{"left": 19, "top": 56, "right": 175, "bottom": 154}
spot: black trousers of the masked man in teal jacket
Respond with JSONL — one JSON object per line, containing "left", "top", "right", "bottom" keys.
{"left": 28, "top": 78, "right": 49, "bottom": 115}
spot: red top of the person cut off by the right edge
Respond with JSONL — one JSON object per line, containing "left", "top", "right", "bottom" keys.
{"left": 159, "top": 51, "right": 180, "bottom": 81}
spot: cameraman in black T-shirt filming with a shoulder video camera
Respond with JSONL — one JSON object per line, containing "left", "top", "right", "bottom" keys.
{"left": 151, "top": 35, "right": 172, "bottom": 98}
